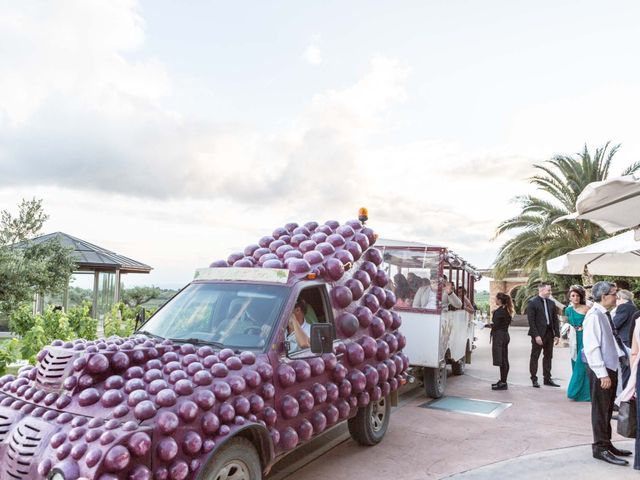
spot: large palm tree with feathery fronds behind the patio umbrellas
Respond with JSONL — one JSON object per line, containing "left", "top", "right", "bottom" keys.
{"left": 494, "top": 142, "right": 640, "bottom": 306}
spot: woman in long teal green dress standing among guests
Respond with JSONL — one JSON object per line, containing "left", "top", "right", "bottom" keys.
{"left": 564, "top": 285, "right": 591, "bottom": 402}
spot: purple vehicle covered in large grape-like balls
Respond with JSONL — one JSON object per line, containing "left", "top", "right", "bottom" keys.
{"left": 0, "top": 221, "right": 409, "bottom": 480}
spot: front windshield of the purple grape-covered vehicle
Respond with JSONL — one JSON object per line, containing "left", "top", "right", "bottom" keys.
{"left": 141, "top": 283, "right": 288, "bottom": 349}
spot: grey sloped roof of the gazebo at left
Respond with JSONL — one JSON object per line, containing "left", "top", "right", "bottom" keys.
{"left": 31, "top": 232, "right": 152, "bottom": 273}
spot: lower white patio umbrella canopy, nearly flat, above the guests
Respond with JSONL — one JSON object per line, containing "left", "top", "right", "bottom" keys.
{"left": 547, "top": 231, "right": 640, "bottom": 277}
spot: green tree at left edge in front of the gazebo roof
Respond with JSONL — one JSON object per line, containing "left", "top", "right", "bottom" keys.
{"left": 0, "top": 198, "right": 75, "bottom": 315}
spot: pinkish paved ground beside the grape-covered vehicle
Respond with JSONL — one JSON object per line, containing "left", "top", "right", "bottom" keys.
{"left": 286, "top": 327, "right": 640, "bottom": 480}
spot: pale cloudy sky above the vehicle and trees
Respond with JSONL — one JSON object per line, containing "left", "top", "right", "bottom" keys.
{"left": 0, "top": 0, "right": 640, "bottom": 287}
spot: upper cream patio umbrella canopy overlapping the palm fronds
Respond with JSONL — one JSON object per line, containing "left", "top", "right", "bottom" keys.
{"left": 554, "top": 175, "right": 640, "bottom": 240}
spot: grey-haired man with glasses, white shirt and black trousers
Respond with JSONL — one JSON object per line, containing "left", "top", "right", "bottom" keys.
{"left": 582, "top": 282, "right": 631, "bottom": 465}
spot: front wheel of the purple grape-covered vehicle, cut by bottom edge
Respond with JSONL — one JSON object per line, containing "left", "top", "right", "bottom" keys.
{"left": 199, "top": 438, "right": 262, "bottom": 480}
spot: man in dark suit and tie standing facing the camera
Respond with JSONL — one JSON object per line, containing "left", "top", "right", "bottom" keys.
{"left": 527, "top": 282, "right": 560, "bottom": 388}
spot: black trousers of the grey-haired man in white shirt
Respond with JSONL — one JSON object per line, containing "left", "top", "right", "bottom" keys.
{"left": 587, "top": 368, "right": 618, "bottom": 450}
